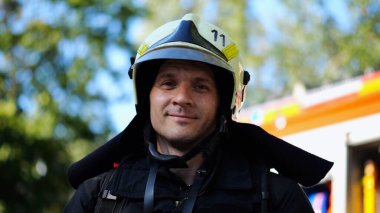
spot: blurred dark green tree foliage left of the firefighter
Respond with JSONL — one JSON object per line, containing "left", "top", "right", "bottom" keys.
{"left": 0, "top": 0, "right": 139, "bottom": 212}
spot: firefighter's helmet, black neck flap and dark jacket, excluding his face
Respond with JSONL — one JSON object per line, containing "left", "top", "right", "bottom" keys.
{"left": 65, "top": 14, "right": 332, "bottom": 212}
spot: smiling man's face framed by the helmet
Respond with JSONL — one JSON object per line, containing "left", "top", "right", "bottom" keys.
{"left": 149, "top": 60, "right": 219, "bottom": 151}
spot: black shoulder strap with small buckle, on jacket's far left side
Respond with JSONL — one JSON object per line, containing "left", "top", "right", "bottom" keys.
{"left": 95, "top": 170, "right": 125, "bottom": 213}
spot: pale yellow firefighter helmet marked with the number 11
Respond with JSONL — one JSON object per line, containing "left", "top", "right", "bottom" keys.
{"left": 130, "top": 14, "right": 249, "bottom": 120}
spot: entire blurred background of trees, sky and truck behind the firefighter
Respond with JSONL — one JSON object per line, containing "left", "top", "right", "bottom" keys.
{"left": 0, "top": 0, "right": 380, "bottom": 213}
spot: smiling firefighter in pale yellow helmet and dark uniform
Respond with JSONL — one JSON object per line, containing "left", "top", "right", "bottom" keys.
{"left": 65, "top": 14, "right": 332, "bottom": 213}
